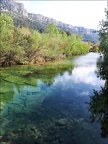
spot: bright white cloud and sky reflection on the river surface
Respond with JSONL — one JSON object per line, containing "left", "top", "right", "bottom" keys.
{"left": 53, "top": 53, "right": 104, "bottom": 96}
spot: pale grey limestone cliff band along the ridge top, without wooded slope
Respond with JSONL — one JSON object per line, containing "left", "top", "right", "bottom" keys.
{"left": 0, "top": 0, "right": 99, "bottom": 42}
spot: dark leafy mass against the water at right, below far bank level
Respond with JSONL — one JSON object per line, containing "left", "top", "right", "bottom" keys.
{"left": 89, "top": 55, "right": 108, "bottom": 137}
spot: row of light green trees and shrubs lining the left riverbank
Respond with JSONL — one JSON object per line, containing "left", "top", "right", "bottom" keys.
{"left": 0, "top": 14, "right": 89, "bottom": 66}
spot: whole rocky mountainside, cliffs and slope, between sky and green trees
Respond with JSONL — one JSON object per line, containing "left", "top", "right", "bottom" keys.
{"left": 0, "top": 0, "right": 99, "bottom": 42}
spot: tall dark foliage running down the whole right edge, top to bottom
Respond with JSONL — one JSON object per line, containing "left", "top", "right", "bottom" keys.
{"left": 89, "top": 11, "right": 108, "bottom": 137}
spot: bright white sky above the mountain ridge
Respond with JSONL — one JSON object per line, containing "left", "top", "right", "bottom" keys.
{"left": 17, "top": 0, "right": 107, "bottom": 29}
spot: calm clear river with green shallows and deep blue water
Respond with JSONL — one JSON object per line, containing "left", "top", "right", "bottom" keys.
{"left": 0, "top": 53, "right": 108, "bottom": 144}
